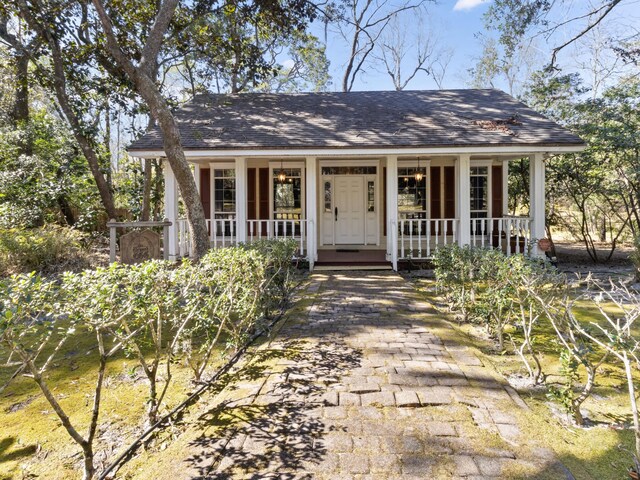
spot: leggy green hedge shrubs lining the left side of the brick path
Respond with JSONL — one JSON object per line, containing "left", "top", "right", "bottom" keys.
{"left": 0, "top": 241, "right": 296, "bottom": 478}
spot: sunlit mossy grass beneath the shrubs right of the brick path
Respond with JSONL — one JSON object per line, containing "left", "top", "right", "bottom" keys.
{"left": 416, "top": 279, "right": 640, "bottom": 480}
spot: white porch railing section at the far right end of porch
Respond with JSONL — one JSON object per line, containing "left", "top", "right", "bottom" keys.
{"left": 471, "top": 217, "right": 531, "bottom": 256}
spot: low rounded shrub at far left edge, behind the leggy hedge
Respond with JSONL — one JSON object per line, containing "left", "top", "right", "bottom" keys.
{"left": 0, "top": 225, "right": 86, "bottom": 276}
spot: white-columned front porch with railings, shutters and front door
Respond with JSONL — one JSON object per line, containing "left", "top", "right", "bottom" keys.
{"left": 165, "top": 152, "right": 545, "bottom": 270}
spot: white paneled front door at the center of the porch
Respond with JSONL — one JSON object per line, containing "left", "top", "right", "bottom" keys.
{"left": 333, "top": 175, "right": 365, "bottom": 245}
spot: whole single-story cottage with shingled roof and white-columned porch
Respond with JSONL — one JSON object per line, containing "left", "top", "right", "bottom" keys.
{"left": 129, "top": 89, "right": 584, "bottom": 269}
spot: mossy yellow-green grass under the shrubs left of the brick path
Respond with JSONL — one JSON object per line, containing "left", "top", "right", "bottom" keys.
{"left": 0, "top": 322, "right": 230, "bottom": 480}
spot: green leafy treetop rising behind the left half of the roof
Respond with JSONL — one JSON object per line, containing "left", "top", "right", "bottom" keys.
{"left": 178, "top": 2, "right": 328, "bottom": 95}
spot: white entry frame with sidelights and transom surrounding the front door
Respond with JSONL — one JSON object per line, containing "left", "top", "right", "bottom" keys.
{"left": 317, "top": 158, "right": 383, "bottom": 246}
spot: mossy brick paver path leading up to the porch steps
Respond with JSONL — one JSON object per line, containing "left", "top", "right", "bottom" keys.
{"left": 186, "top": 272, "right": 565, "bottom": 479}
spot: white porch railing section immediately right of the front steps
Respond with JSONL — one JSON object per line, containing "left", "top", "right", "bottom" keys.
{"left": 398, "top": 218, "right": 458, "bottom": 259}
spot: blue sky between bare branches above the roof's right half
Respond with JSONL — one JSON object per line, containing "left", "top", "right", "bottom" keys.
{"left": 312, "top": 0, "right": 640, "bottom": 91}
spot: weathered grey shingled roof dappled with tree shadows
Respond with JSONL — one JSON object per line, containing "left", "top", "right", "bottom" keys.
{"left": 129, "top": 89, "right": 584, "bottom": 153}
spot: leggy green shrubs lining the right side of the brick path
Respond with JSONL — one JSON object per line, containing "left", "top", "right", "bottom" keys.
{"left": 434, "top": 245, "right": 640, "bottom": 456}
